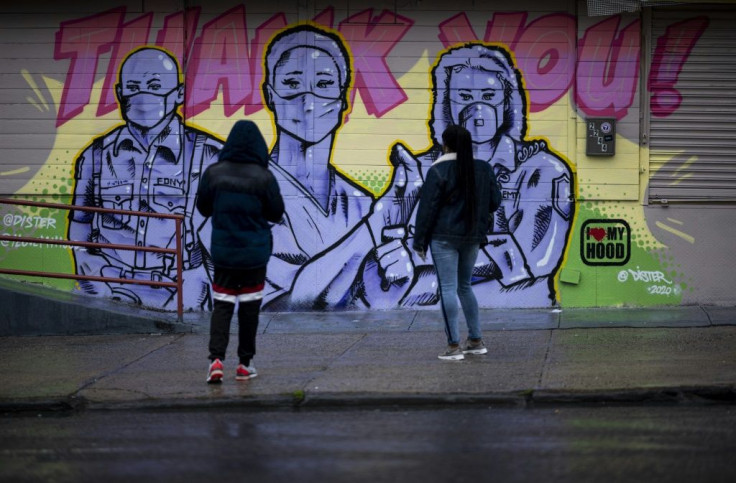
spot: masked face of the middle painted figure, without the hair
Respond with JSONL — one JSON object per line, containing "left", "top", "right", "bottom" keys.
{"left": 268, "top": 47, "right": 344, "bottom": 143}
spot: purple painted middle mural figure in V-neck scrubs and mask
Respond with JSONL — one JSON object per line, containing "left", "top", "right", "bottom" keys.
{"left": 263, "top": 26, "right": 420, "bottom": 309}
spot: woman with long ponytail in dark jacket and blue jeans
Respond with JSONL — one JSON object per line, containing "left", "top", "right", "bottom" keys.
{"left": 412, "top": 125, "right": 501, "bottom": 360}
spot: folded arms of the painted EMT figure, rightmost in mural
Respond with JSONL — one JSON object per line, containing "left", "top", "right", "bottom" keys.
{"left": 360, "top": 142, "right": 574, "bottom": 307}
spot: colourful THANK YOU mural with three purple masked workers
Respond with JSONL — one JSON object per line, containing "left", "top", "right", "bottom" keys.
{"left": 0, "top": 4, "right": 712, "bottom": 310}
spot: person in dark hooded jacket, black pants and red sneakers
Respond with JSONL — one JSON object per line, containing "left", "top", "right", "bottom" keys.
{"left": 197, "top": 121, "right": 284, "bottom": 383}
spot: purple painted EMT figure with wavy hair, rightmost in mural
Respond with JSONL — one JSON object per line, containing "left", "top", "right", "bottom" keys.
{"left": 366, "top": 43, "right": 574, "bottom": 307}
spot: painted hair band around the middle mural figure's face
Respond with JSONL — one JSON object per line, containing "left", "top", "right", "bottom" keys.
{"left": 263, "top": 25, "right": 351, "bottom": 92}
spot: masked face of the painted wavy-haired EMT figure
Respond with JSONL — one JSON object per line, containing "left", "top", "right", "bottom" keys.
{"left": 450, "top": 68, "right": 504, "bottom": 143}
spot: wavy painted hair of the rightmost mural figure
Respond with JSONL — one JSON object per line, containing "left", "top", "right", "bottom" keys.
{"left": 429, "top": 43, "right": 526, "bottom": 145}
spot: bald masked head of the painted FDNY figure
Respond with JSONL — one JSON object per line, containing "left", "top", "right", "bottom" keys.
{"left": 116, "top": 50, "right": 184, "bottom": 131}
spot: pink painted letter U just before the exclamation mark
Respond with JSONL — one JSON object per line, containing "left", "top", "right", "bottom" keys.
{"left": 576, "top": 17, "right": 640, "bottom": 119}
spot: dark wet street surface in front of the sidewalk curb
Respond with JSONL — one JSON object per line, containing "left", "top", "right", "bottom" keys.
{"left": 0, "top": 405, "right": 736, "bottom": 483}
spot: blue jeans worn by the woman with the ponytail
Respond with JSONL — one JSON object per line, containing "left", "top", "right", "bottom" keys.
{"left": 430, "top": 240, "right": 481, "bottom": 345}
